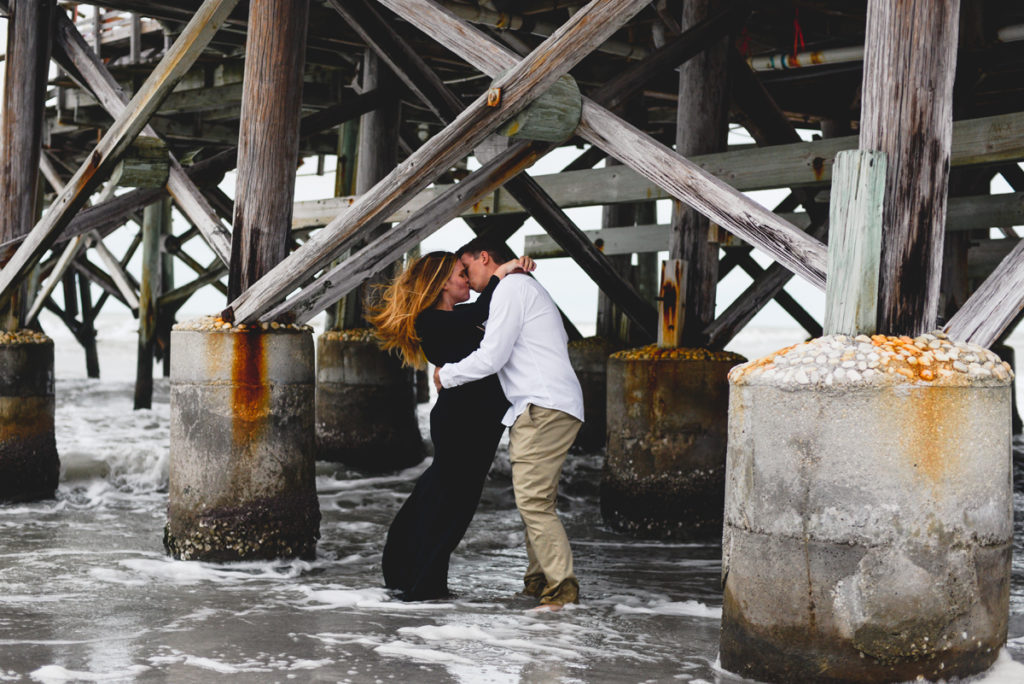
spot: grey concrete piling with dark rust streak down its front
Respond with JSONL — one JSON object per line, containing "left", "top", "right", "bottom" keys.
{"left": 164, "top": 318, "right": 319, "bottom": 561}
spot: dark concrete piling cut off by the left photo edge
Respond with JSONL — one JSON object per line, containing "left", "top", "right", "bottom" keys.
{"left": 0, "top": 330, "right": 60, "bottom": 502}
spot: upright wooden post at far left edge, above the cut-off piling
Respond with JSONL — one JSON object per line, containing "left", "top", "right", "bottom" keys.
{"left": 0, "top": 0, "right": 56, "bottom": 331}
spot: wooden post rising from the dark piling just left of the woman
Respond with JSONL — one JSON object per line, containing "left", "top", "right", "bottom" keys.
{"left": 340, "top": 49, "right": 401, "bottom": 330}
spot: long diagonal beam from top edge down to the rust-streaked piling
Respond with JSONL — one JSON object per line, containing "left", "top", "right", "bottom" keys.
{"left": 225, "top": 0, "right": 646, "bottom": 323}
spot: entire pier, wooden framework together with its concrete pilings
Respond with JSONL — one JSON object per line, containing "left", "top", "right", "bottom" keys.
{"left": 0, "top": 0, "right": 1024, "bottom": 682}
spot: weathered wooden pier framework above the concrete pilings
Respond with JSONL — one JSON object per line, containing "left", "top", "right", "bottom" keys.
{"left": 0, "top": 0, "right": 1024, "bottom": 385}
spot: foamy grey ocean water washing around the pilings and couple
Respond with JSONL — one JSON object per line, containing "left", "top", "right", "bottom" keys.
{"left": 0, "top": 317, "right": 1024, "bottom": 684}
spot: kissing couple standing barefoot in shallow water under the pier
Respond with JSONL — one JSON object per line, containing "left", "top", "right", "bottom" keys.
{"left": 370, "top": 238, "right": 584, "bottom": 609}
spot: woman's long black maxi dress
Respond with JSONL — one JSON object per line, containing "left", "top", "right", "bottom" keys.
{"left": 382, "top": 277, "right": 509, "bottom": 601}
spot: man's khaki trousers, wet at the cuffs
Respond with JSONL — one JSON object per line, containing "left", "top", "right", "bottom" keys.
{"left": 509, "top": 404, "right": 583, "bottom": 603}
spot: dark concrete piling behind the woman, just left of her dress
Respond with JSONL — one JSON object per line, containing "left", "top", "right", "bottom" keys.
{"left": 316, "top": 329, "right": 424, "bottom": 472}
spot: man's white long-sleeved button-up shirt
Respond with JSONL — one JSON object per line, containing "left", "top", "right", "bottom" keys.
{"left": 440, "top": 273, "right": 583, "bottom": 426}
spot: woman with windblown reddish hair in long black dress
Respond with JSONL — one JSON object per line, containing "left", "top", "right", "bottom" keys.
{"left": 370, "top": 252, "right": 532, "bottom": 601}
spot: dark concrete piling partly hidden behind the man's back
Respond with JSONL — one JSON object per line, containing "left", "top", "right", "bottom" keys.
{"left": 569, "top": 337, "right": 616, "bottom": 454}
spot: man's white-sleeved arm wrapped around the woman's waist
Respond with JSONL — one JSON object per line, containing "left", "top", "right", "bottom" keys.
{"left": 437, "top": 276, "right": 525, "bottom": 387}
